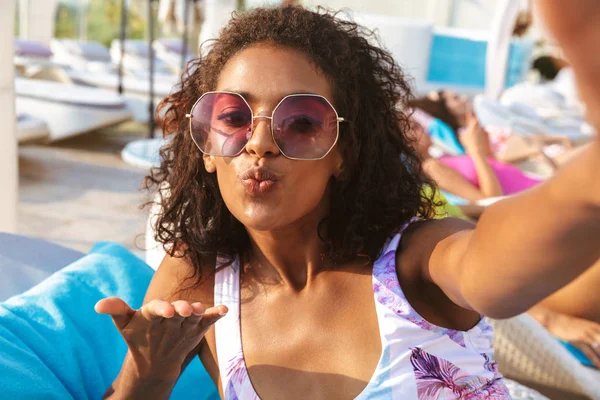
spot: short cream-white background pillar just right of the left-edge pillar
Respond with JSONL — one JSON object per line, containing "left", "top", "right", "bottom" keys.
{"left": 17, "top": 0, "right": 58, "bottom": 45}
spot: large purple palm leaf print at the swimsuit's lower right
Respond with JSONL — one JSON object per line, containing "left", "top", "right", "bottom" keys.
{"left": 410, "top": 348, "right": 510, "bottom": 400}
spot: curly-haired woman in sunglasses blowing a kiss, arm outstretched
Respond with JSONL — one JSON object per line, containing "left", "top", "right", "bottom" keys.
{"left": 96, "top": 0, "right": 600, "bottom": 399}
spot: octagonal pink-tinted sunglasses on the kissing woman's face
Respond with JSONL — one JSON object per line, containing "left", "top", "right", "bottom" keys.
{"left": 186, "top": 92, "right": 344, "bottom": 160}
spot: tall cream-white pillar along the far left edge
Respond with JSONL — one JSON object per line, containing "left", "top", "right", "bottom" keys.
{"left": 0, "top": 0, "right": 19, "bottom": 232}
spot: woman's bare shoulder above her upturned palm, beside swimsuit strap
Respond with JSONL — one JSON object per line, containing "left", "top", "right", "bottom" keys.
{"left": 144, "top": 254, "right": 214, "bottom": 307}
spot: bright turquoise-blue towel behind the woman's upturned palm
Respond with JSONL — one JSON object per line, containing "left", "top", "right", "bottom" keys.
{"left": 0, "top": 243, "right": 218, "bottom": 400}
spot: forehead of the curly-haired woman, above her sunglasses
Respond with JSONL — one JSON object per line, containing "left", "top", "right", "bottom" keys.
{"left": 216, "top": 44, "right": 333, "bottom": 105}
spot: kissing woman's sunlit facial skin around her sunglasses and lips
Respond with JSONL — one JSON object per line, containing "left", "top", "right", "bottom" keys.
{"left": 204, "top": 46, "right": 343, "bottom": 241}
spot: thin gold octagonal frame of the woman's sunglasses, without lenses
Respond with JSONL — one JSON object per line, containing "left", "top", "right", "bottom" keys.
{"left": 185, "top": 91, "right": 345, "bottom": 161}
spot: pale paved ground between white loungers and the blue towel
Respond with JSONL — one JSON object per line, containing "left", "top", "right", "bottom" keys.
{"left": 18, "top": 124, "right": 156, "bottom": 256}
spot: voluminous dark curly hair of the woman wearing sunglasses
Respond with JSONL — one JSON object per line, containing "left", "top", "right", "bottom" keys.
{"left": 145, "top": 6, "right": 436, "bottom": 282}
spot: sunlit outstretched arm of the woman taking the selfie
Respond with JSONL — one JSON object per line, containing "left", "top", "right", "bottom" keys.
{"left": 423, "top": 0, "right": 600, "bottom": 318}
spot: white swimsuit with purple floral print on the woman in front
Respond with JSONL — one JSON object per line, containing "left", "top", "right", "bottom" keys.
{"left": 215, "top": 227, "right": 510, "bottom": 400}
